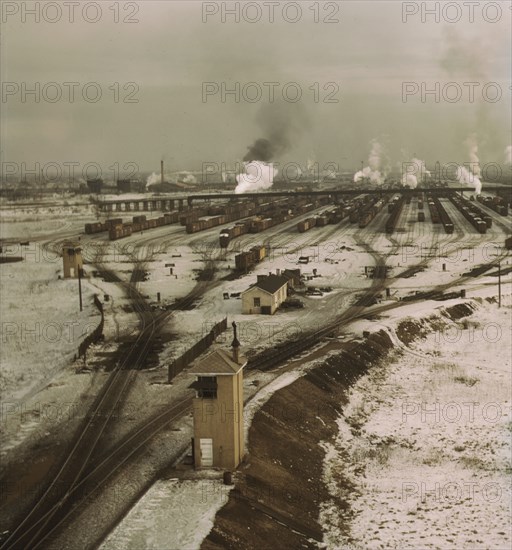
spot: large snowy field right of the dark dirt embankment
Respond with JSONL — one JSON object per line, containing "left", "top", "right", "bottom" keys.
{"left": 321, "top": 290, "right": 512, "bottom": 550}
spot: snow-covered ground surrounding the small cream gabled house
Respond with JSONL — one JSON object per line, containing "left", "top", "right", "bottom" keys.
{"left": 162, "top": 224, "right": 375, "bottom": 362}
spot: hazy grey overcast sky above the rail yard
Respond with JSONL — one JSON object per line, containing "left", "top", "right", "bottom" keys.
{"left": 1, "top": 0, "right": 511, "bottom": 179}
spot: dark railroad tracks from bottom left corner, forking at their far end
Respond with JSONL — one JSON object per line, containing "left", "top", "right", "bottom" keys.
{"left": 0, "top": 234, "right": 220, "bottom": 549}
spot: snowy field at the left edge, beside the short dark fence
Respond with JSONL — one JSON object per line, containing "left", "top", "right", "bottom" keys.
{"left": 0, "top": 247, "right": 100, "bottom": 401}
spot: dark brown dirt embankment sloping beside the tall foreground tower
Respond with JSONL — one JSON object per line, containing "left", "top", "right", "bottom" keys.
{"left": 202, "top": 331, "right": 393, "bottom": 550}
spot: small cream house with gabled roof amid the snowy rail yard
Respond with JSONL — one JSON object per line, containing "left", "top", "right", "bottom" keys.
{"left": 242, "top": 275, "right": 288, "bottom": 315}
